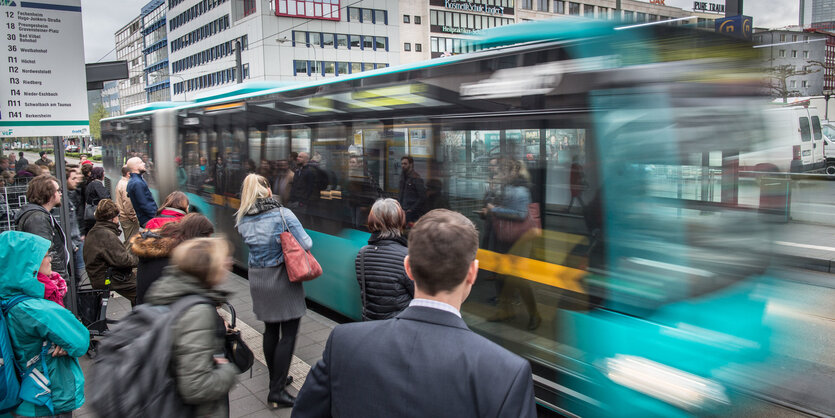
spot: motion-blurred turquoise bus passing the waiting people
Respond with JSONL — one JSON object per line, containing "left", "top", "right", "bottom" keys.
{"left": 102, "top": 21, "right": 835, "bottom": 417}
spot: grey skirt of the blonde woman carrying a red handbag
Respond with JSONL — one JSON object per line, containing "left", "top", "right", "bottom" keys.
{"left": 249, "top": 263, "right": 307, "bottom": 322}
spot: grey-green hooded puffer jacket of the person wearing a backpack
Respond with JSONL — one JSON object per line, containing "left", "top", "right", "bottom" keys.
{"left": 145, "top": 266, "right": 238, "bottom": 417}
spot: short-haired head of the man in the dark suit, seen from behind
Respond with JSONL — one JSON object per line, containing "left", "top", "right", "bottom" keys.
{"left": 409, "top": 209, "right": 478, "bottom": 296}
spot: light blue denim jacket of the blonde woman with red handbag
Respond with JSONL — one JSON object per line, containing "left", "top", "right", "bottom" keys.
{"left": 237, "top": 198, "right": 313, "bottom": 268}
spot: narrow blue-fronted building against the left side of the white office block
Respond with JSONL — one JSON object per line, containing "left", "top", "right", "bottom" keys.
{"left": 140, "top": 0, "right": 171, "bottom": 103}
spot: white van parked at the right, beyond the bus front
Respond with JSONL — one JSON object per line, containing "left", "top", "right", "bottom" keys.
{"left": 739, "top": 106, "right": 826, "bottom": 173}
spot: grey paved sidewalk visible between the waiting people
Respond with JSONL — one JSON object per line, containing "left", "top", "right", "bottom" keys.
{"left": 74, "top": 273, "right": 336, "bottom": 418}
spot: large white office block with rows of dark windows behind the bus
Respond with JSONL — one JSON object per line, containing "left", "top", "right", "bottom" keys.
{"left": 168, "top": 0, "right": 400, "bottom": 100}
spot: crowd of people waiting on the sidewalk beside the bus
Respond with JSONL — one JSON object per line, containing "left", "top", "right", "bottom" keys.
{"left": 0, "top": 153, "right": 534, "bottom": 416}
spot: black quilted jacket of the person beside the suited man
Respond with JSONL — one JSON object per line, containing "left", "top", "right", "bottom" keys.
{"left": 355, "top": 234, "right": 415, "bottom": 321}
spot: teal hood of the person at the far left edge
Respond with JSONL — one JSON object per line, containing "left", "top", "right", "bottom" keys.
{"left": 0, "top": 231, "right": 47, "bottom": 299}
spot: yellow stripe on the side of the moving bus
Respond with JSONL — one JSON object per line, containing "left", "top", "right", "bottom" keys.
{"left": 476, "top": 249, "right": 586, "bottom": 293}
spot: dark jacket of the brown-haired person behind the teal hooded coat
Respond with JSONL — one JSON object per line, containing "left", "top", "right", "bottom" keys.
{"left": 15, "top": 203, "right": 70, "bottom": 279}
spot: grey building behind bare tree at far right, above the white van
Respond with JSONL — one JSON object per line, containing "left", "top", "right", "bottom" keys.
{"left": 753, "top": 26, "right": 832, "bottom": 98}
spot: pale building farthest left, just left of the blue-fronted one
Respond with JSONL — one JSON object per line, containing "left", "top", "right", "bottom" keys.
{"left": 116, "top": 16, "right": 148, "bottom": 112}
